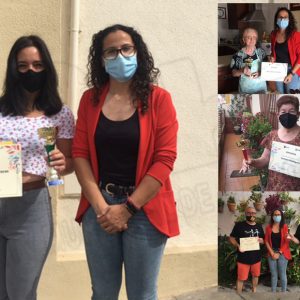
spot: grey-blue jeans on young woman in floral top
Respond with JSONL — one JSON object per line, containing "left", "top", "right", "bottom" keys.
{"left": 0, "top": 188, "right": 53, "bottom": 300}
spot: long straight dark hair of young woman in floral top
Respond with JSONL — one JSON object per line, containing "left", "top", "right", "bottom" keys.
{"left": 0, "top": 35, "right": 63, "bottom": 116}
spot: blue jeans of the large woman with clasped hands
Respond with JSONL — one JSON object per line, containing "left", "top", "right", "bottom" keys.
{"left": 82, "top": 190, "right": 167, "bottom": 300}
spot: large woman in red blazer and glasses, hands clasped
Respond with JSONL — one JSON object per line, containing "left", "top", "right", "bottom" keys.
{"left": 73, "top": 25, "right": 179, "bottom": 300}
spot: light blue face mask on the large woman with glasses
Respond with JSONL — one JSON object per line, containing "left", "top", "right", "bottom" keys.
{"left": 104, "top": 53, "right": 137, "bottom": 82}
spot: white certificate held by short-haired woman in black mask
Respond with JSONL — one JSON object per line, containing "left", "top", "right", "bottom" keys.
{"left": 269, "top": 142, "right": 300, "bottom": 178}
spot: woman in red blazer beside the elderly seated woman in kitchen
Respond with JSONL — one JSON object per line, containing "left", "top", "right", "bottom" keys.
{"left": 270, "top": 7, "right": 300, "bottom": 94}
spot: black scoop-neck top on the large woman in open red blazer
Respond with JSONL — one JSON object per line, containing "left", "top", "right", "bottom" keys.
{"left": 95, "top": 110, "right": 140, "bottom": 186}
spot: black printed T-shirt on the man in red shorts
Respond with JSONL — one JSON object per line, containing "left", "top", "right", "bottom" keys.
{"left": 230, "top": 221, "right": 265, "bottom": 265}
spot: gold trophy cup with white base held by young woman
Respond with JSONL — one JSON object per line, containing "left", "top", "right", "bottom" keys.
{"left": 38, "top": 127, "right": 64, "bottom": 186}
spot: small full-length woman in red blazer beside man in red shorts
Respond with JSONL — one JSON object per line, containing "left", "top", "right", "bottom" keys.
{"left": 265, "top": 209, "right": 295, "bottom": 292}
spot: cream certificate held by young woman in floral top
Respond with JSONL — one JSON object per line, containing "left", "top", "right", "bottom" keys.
{"left": 0, "top": 142, "right": 22, "bottom": 198}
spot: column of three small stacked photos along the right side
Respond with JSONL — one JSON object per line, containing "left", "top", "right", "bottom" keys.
{"left": 218, "top": 3, "right": 300, "bottom": 294}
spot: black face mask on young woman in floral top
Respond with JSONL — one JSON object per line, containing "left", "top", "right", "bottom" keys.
{"left": 19, "top": 70, "right": 46, "bottom": 93}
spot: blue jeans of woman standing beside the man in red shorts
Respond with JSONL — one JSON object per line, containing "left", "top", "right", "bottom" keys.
{"left": 268, "top": 254, "right": 288, "bottom": 292}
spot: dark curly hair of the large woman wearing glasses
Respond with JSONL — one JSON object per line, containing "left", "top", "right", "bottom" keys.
{"left": 87, "top": 24, "right": 160, "bottom": 113}
